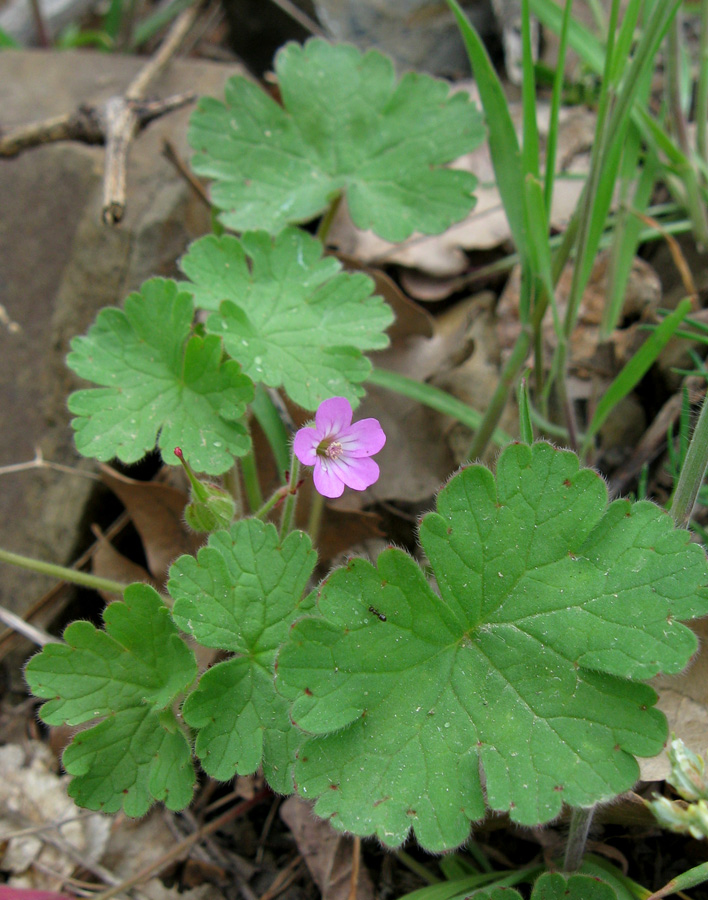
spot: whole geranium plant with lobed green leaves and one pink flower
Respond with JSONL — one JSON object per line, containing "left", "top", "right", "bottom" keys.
{"left": 4, "top": 8, "right": 708, "bottom": 900}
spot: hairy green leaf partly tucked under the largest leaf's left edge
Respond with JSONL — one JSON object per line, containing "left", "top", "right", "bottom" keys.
{"left": 168, "top": 519, "right": 316, "bottom": 793}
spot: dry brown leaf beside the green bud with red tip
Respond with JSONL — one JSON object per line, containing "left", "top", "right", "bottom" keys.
{"left": 101, "top": 466, "right": 204, "bottom": 586}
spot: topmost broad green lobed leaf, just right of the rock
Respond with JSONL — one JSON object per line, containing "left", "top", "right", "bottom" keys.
{"left": 189, "top": 40, "right": 484, "bottom": 241}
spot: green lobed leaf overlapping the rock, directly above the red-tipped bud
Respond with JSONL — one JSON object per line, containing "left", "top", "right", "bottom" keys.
{"left": 67, "top": 278, "right": 253, "bottom": 475}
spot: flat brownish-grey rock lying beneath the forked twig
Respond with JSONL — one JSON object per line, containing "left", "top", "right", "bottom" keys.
{"left": 0, "top": 51, "right": 239, "bottom": 631}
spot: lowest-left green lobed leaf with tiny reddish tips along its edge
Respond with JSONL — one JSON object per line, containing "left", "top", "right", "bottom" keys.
{"left": 25, "top": 584, "right": 197, "bottom": 816}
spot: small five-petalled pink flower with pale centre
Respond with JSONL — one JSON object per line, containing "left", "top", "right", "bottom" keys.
{"left": 293, "top": 397, "right": 386, "bottom": 498}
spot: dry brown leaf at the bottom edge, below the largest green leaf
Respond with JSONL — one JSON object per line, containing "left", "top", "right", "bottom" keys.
{"left": 280, "top": 795, "right": 374, "bottom": 900}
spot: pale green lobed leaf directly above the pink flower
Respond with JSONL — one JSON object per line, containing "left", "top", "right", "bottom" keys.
{"left": 181, "top": 228, "right": 393, "bottom": 410}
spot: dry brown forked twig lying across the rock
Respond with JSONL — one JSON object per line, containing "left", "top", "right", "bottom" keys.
{"left": 0, "top": 3, "right": 199, "bottom": 225}
